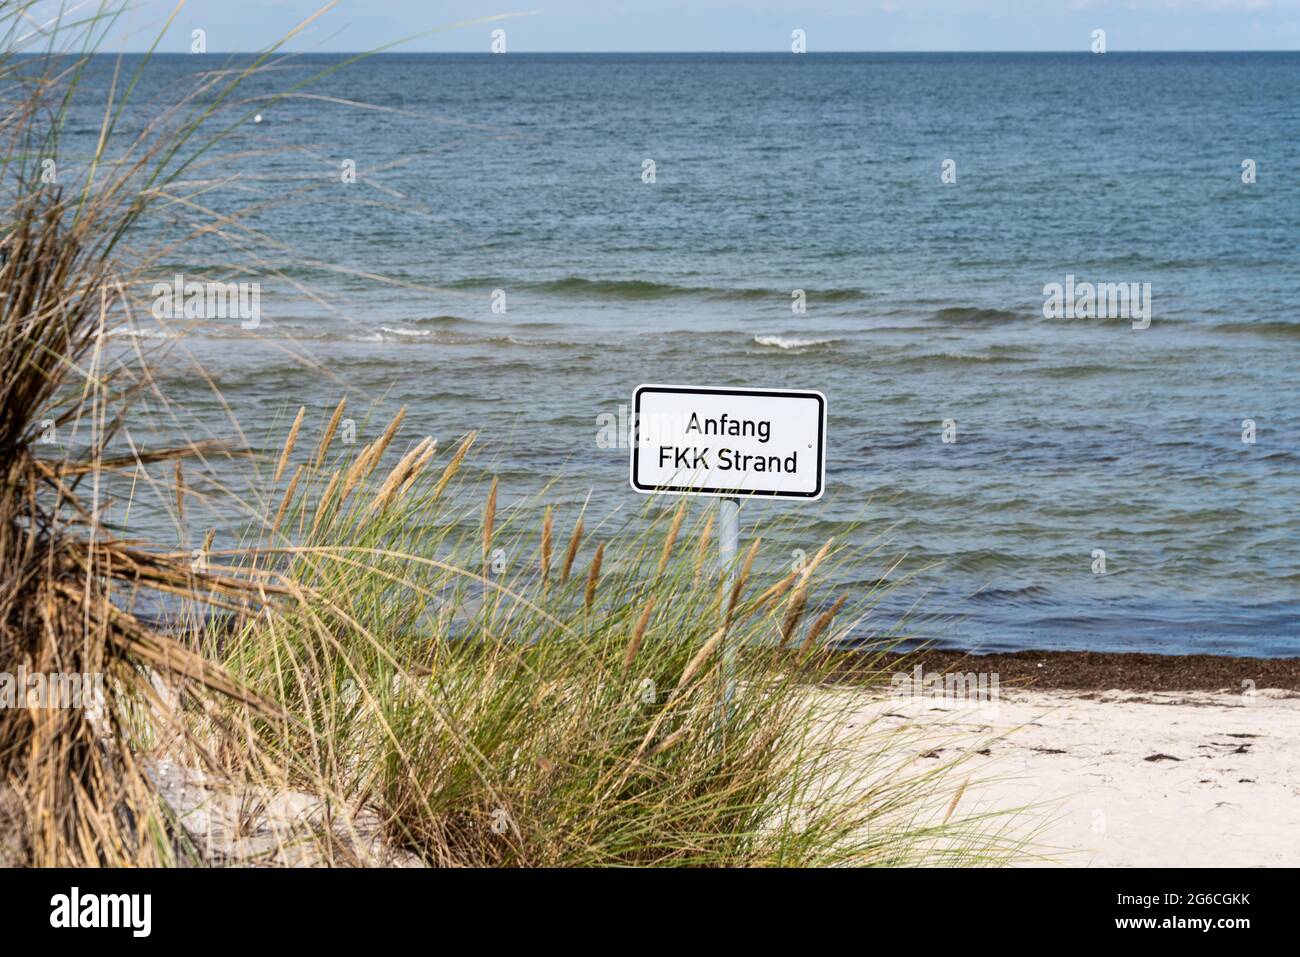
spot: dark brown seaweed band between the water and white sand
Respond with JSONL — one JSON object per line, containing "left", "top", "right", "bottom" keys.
{"left": 836, "top": 649, "right": 1300, "bottom": 693}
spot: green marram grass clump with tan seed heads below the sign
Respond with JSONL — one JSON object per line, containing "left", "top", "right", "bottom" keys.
{"left": 185, "top": 412, "right": 1014, "bottom": 866}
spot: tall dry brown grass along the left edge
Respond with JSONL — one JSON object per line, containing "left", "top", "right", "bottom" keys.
{"left": 0, "top": 0, "right": 325, "bottom": 865}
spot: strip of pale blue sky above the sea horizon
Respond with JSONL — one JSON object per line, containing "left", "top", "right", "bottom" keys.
{"left": 78, "top": 0, "right": 1300, "bottom": 52}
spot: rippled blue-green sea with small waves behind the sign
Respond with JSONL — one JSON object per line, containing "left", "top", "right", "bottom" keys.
{"left": 64, "top": 53, "right": 1300, "bottom": 655}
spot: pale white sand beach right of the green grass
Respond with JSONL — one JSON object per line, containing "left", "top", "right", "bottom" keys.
{"left": 862, "top": 689, "right": 1300, "bottom": 867}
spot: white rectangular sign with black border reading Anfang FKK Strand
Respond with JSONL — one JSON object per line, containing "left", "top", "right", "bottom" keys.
{"left": 632, "top": 385, "right": 826, "bottom": 499}
